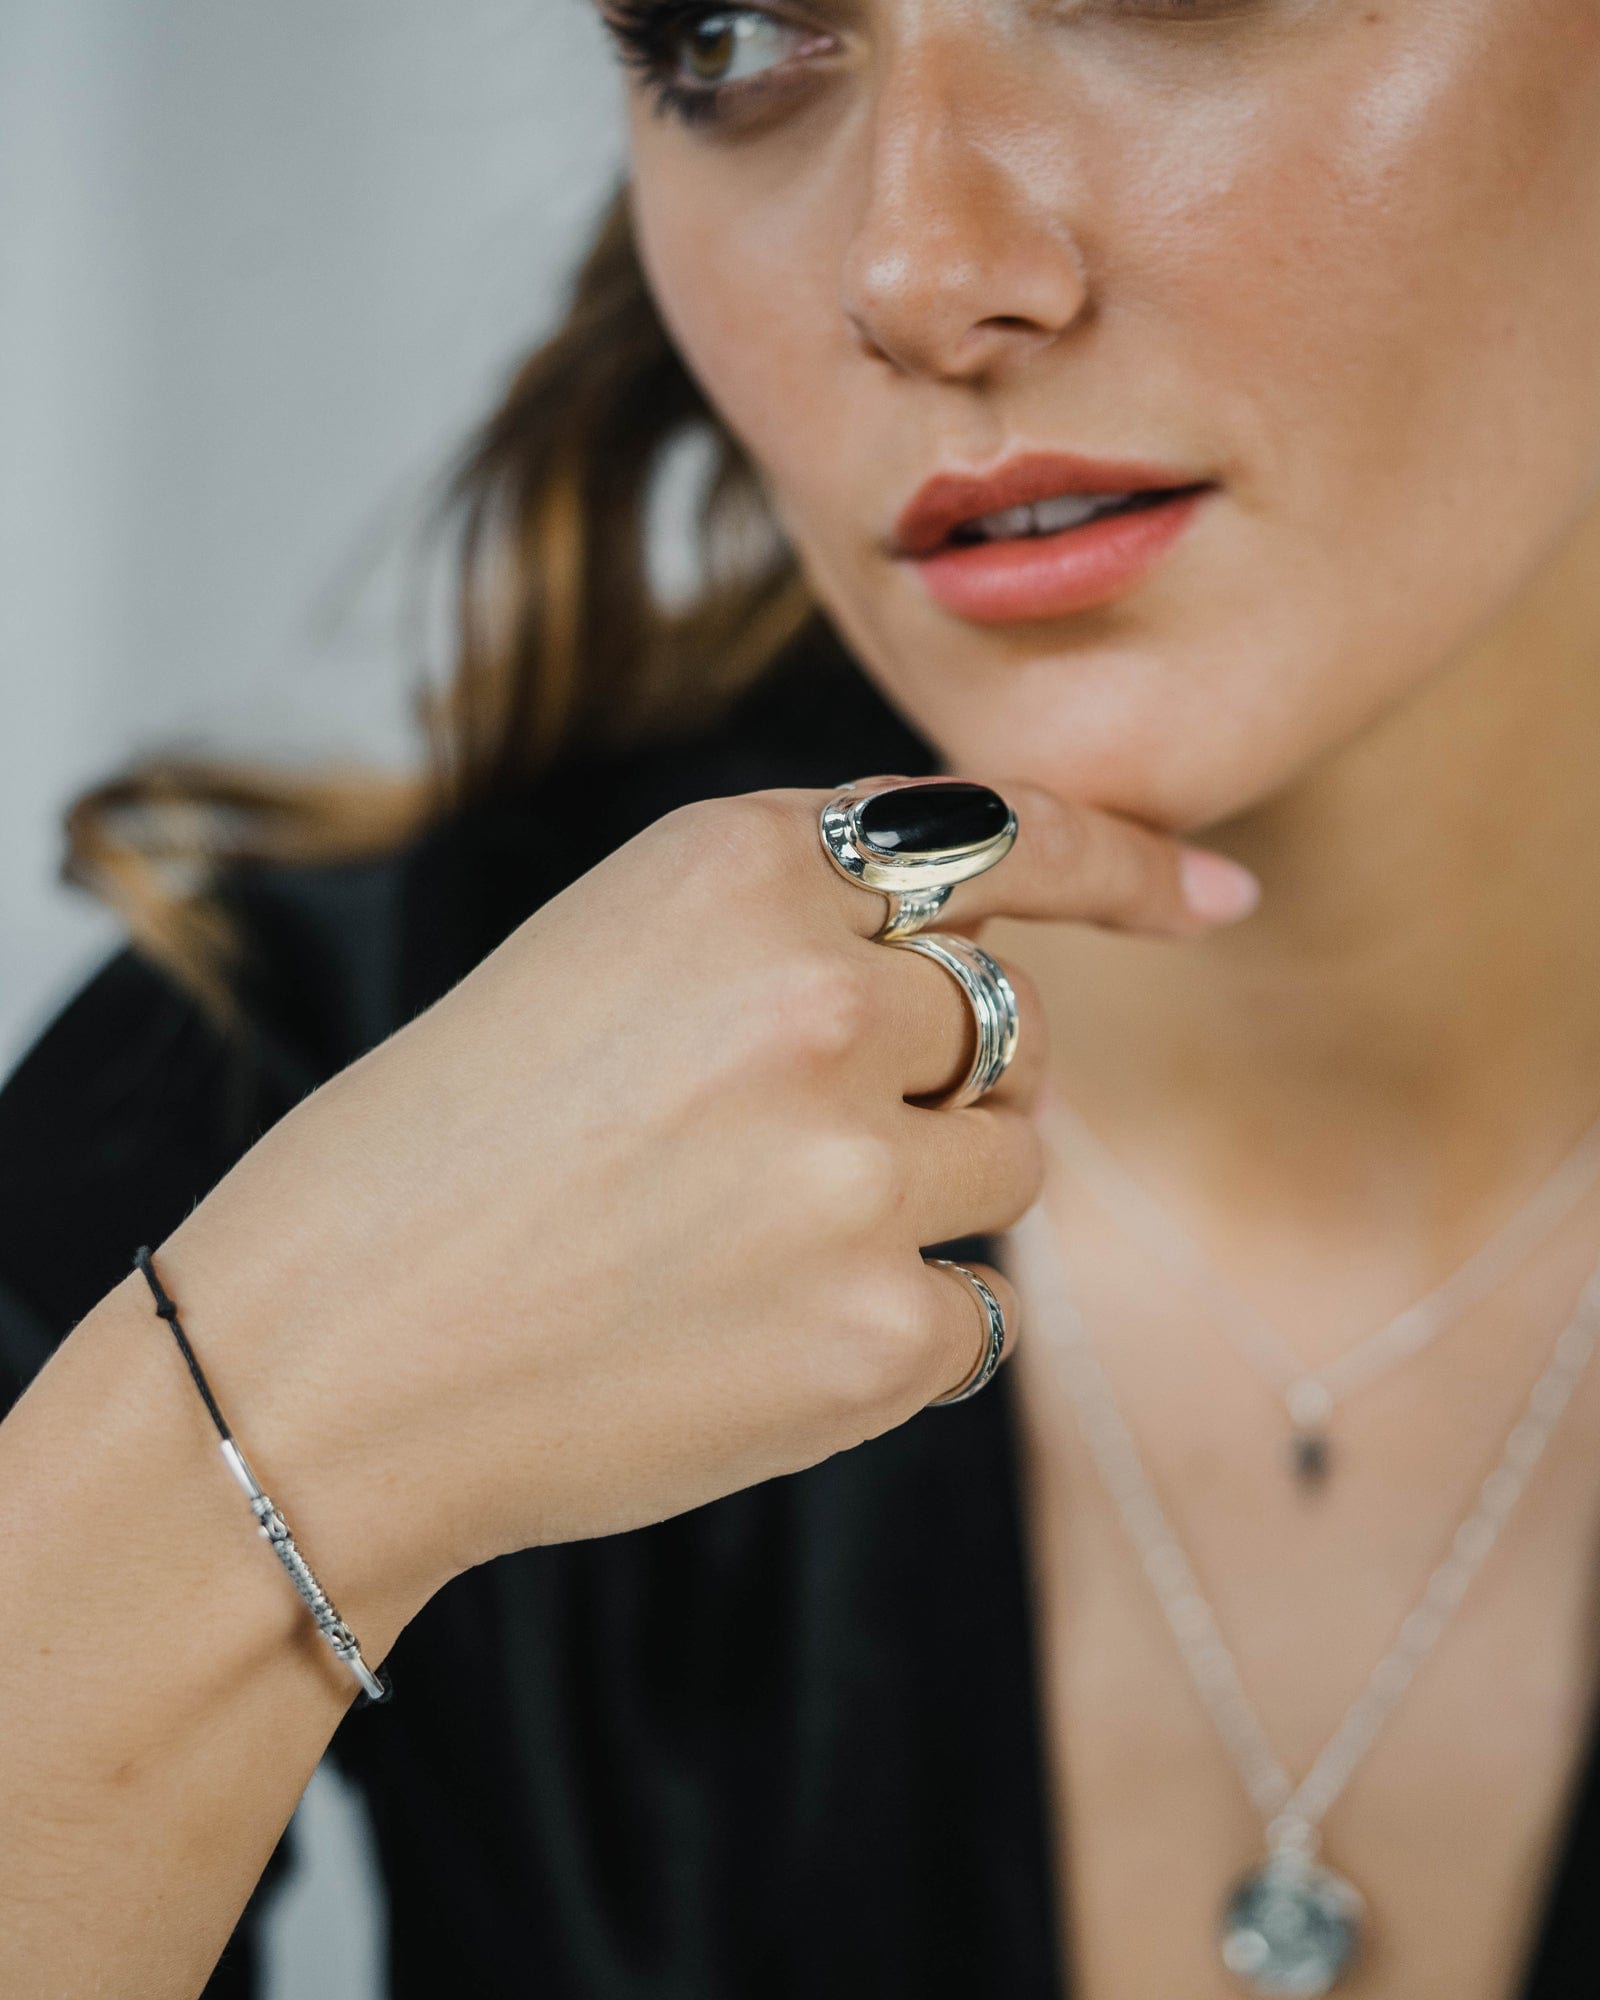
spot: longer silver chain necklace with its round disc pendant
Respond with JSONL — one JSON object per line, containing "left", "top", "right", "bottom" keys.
{"left": 1008, "top": 1200, "right": 1600, "bottom": 2000}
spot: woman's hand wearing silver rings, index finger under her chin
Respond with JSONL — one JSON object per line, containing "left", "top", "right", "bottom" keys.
{"left": 144, "top": 780, "right": 1256, "bottom": 1622}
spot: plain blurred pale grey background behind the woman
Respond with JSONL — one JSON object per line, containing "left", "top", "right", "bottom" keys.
{"left": 0, "top": 0, "right": 624, "bottom": 2000}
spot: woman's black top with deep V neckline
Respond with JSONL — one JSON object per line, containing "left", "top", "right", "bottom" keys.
{"left": 0, "top": 650, "right": 1600, "bottom": 2000}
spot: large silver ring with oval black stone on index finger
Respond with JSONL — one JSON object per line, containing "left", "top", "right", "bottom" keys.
{"left": 820, "top": 778, "right": 1016, "bottom": 944}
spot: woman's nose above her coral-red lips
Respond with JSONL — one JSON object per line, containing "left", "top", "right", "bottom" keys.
{"left": 840, "top": 34, "right": 1090, "bottom": 380}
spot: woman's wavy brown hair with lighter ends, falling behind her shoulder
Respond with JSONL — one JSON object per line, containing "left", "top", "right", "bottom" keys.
{"left": 60, "top": 184, "right": 816, "bottom": 1030}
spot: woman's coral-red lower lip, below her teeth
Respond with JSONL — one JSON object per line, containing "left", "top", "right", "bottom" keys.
{"left": 900, "top": 486, "right": 1216, "bottom": 624}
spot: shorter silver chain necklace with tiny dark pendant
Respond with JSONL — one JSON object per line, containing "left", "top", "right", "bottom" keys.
{"left": 1040, "top": 1086, "right": 1600, "bottom": 1486}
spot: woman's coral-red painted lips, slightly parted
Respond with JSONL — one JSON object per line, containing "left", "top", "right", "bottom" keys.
{"left": 890, "top": 452, "right": 1216, "bottom": 624}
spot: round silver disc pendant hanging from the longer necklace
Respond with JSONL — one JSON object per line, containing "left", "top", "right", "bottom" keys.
{"left": 1222, "top": 1850, "right": 1364, "bottom": 2000}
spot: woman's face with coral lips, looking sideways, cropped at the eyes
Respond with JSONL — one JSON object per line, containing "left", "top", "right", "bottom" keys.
{"left": 606, "top": 0, "right": 1600, "bottom": 830}
